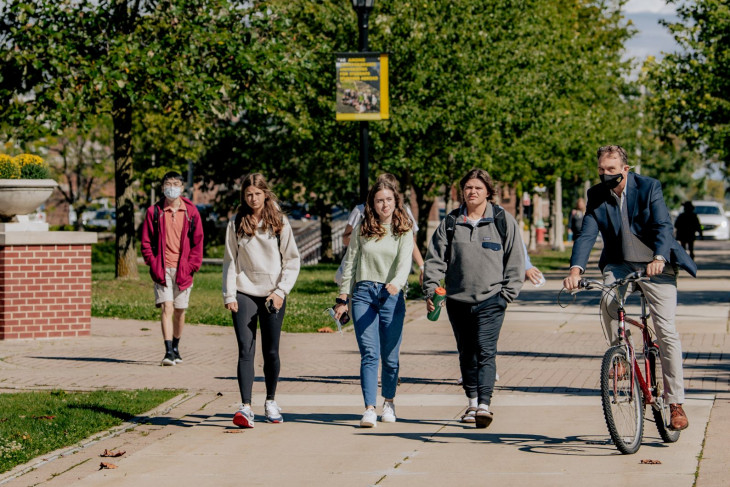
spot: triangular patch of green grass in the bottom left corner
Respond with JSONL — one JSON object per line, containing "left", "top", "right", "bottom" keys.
{"left": 0, "top": 389, "right": 182, "bottom": 473}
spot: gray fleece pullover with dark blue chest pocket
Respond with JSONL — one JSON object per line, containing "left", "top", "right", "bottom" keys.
{"left": 423, "top": 203, "right": 525, "bottom": 304}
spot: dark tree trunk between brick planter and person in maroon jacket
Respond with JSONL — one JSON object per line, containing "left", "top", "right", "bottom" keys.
{"left": 112, "top": 96, "right": 139, "bottom": 279}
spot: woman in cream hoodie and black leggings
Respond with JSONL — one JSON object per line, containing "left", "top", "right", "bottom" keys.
{"left": 223, "top": 173, "right": 300, "bottom": 428}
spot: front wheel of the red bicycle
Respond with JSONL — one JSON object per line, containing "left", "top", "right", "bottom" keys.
{"left": 601, "top": 346, "right": 644, "bottom": 454}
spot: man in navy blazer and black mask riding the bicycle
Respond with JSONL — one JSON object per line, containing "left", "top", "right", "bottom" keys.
{"left": 563, "top": 145, "right": 697, "bottom": 430}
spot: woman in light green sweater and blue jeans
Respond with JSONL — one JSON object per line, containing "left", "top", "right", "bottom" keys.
{"left": 335, "top": 180, "right": 413, "bottom": 428}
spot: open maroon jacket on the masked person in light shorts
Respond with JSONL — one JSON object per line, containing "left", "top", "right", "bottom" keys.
{"left": 142, "top": 198, "right": 203, "bottom": 291}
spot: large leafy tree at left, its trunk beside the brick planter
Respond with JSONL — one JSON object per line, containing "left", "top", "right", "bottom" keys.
{"left": 0, "top": 0, "right": 284, "bottom": 278}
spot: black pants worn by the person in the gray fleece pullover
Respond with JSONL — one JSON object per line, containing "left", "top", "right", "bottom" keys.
{"left": 446, "top": 294, "right": 507, "bottom": 405}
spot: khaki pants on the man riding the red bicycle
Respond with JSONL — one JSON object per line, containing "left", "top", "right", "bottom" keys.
{"left": 601, "top": 262, "right": 684, "bottom": 404}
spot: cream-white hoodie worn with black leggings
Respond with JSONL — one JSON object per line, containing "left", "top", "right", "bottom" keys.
{"left": 223, "top": 217, "right": 300, "bottom": 304}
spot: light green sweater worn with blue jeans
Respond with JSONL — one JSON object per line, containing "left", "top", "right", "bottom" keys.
{"left": 340, "top": 224, "right": 413, "bottom": 294}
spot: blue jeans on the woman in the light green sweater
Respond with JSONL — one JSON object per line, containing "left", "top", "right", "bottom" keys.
{"left": 352, "top": 281, "right": 406, "bottom": 407}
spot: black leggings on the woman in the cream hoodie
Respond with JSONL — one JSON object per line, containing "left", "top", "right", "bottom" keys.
{"left": 232, "top": 293, "right": 286, "bottom": 404}
